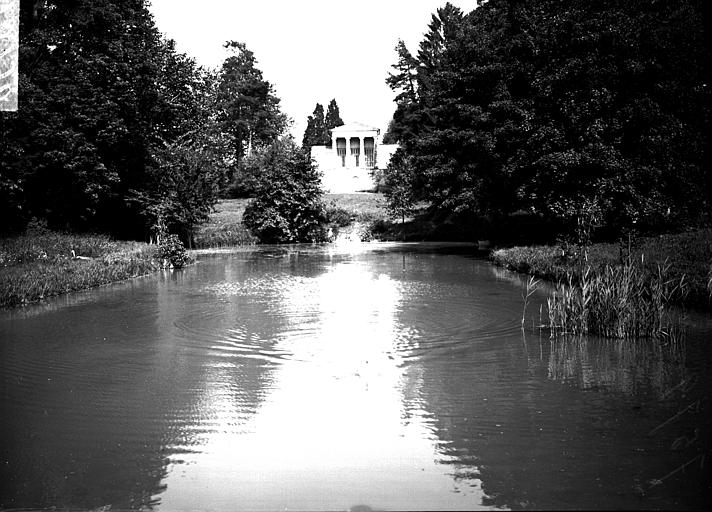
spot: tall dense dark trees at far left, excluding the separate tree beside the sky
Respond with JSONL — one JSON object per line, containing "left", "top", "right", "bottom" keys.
{"left": 0, "top": 0, "right": 228, "bottom": 236}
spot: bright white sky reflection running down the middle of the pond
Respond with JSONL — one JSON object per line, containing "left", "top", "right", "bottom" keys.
{"left": 161, "top": 263, "right": 481, "bottom": 510}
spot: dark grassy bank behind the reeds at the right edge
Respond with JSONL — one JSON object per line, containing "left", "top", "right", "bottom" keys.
{"left": 491, "top": 229, "right": 712, "bottom": 308}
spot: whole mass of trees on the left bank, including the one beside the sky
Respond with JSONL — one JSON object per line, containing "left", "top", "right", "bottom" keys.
{"left": 0, "top": 0, "right": 287, "bottom": 239}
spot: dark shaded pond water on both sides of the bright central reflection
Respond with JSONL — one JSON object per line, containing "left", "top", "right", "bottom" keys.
{"left": 0, "top": 244, "right": 712, "bottom": 512}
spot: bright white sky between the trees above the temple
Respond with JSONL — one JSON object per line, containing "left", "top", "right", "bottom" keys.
{"left": 151, "top": 0, "right": 476, "bottom": 142}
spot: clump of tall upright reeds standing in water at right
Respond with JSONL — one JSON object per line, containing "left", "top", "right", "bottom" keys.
{"left": 547, "top": 257, "right": 688, "bottom": 339}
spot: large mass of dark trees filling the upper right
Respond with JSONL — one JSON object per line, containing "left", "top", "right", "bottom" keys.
{"left": 386, "top": 0, "right": 712, "bottom": 240}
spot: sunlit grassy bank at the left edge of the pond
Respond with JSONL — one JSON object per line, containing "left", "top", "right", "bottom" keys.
{"left": 0, "top": 229, "right": 161, "bottom": 307}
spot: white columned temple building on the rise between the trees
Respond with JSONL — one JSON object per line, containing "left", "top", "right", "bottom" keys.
{"left": 311, "top": 123, "right": 398, "bottom": 194}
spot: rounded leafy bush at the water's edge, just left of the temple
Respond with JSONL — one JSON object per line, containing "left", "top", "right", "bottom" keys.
{"left": 243, "top": 137, "right": 327, "bottom": 243}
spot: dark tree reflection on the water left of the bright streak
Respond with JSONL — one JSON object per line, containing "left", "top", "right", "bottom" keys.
{"left": 0, "top": 258, "right": 290, "bottom": 509}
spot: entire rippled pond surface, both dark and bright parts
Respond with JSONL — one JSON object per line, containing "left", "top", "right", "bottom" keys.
{"left": 0, "top": 244, "right": 712, "bottom": 511}
